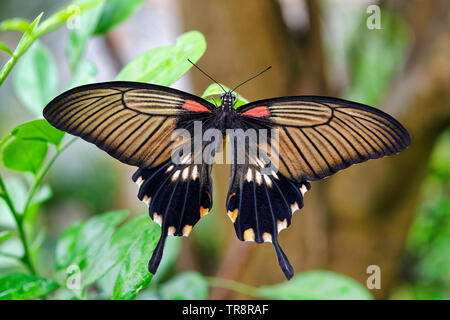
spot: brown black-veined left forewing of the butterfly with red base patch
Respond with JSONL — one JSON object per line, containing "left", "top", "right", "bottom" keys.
{"left": 44, "top": 82, "right": 214, "bottom": 167}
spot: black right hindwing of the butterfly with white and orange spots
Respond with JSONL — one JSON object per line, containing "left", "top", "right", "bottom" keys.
{"left": 226, "top": 131, "right": 310, "bottom": 279}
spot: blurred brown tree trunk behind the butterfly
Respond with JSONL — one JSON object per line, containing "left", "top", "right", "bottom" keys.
{"left": 180, "top": 0, "right": 450, "bottom": 298}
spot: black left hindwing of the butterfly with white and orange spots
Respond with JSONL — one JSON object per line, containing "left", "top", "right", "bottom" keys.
{"left": 133, "top": 160, "right": 212, "bottom": 274}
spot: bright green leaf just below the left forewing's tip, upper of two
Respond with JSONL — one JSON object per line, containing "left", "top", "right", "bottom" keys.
{"left": 11, "top": 119, "right": 64, "bottom": 146}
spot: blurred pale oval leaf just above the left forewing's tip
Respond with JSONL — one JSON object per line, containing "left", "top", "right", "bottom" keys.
{"left": 13, "top": 42, "right": 59, "bottom": 117}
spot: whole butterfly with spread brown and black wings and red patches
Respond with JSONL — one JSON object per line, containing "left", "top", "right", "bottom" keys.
{"left": 43, "top": 71, "right": 411, "bottom": 279}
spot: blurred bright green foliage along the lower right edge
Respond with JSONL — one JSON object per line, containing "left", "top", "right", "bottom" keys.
{"left": 393, "top": 130, "right": 450, "bottom": 299}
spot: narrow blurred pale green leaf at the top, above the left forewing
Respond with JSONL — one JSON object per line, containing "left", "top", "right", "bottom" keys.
{"left": 66, "top": 4, "right": 103, "bottom": 71}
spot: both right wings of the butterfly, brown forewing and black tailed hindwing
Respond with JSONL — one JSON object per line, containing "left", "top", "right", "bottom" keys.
{"left": 227, "top": 97, "right": 411, "bottom": 279}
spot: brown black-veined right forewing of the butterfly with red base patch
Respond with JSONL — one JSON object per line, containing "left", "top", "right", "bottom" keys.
{"left": 237, "top": 96, "right": 411, "bottom": 182}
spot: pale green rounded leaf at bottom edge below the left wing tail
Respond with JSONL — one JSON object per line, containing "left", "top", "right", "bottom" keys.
{"left": 159, "top": 271, "right": 208, "bottom": 300}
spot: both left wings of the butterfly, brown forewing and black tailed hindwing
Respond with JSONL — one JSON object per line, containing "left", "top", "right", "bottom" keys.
{"left": 44, "top": 82, "right": 215, "bottom": 273}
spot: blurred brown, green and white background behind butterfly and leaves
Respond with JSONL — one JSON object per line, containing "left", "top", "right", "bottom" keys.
{"left": 0, "top": 0, "right": 450, "bottom": 299}
